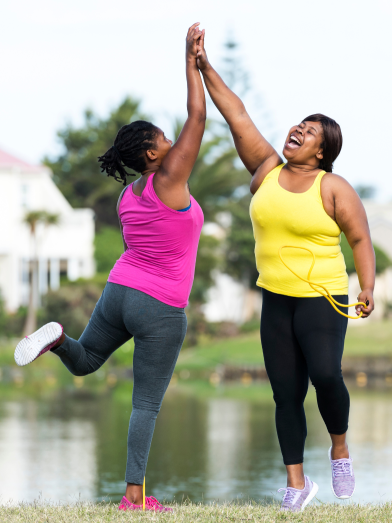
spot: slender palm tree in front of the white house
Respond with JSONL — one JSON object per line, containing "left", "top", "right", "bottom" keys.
{"left": 23, "top": 211, "right": 59, "bottom": 336}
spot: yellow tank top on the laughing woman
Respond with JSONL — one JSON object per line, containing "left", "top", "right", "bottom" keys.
{"left": 250, "top": 163, "right": 348, "bottom": 298}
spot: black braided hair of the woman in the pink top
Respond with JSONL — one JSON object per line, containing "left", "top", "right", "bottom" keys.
{"left": 98, "top": 120, "right": 158, "bottom": 185}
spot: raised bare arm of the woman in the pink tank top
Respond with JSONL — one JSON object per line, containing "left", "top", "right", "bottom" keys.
{"left": 157, "top": 23, "right": 206, "bottom": 190}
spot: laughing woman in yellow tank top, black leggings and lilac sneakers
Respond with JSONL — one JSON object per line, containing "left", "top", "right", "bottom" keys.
{"left": 197, "top": 35, "right": 375, "bottom": 511}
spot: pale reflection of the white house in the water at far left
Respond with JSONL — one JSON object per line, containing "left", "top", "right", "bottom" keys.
{"left": 0, "top": 401, "right": 97, "bottom": 502}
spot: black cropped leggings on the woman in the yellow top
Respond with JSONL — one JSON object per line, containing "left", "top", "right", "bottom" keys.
{"left": 261, "top": 289, "right": 350, "bottom": 465}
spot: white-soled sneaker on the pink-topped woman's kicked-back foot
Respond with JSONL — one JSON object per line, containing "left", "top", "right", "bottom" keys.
{"left": 14, "top": 321, "right": 63, "bottom": 367}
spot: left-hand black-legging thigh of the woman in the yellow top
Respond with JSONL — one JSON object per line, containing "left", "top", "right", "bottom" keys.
{"left": 260, "top": 289, "right": 308, "bottom": 399}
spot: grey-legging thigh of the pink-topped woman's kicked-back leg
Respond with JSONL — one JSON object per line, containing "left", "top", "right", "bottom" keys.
{"left": 79, "top": 284, "right": 132, "bottom": 368}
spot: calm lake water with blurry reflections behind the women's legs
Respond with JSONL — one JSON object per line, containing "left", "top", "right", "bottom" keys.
{"left": 0, "top": 382, "right": 392, "bottom": 503}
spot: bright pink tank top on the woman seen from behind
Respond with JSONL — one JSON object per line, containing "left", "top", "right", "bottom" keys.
{"left": 108, "top": 174, "right": 204, "bottom": 308}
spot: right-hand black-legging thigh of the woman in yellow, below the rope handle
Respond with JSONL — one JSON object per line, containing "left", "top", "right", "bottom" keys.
{"left": 294, "top": 296, "right": 348, "bottom": 381}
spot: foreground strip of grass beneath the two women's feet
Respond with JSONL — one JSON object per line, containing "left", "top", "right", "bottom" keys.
{"left": 0, "top": 503, "right": 392, "bottom": 523}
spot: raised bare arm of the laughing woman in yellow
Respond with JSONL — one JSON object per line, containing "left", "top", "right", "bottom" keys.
{"left": 197, "top": 32, "right": 283, "bottom": 192}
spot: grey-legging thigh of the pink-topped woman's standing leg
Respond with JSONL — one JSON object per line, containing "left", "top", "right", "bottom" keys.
{"left": 125, "top": 289, "right": 187, "bottom": 412}
